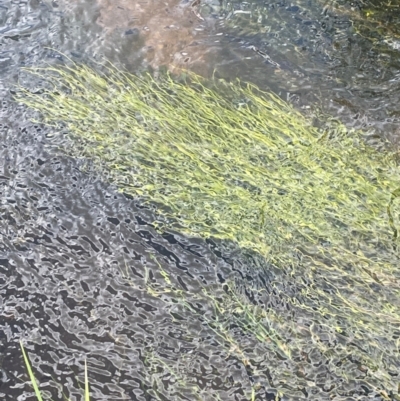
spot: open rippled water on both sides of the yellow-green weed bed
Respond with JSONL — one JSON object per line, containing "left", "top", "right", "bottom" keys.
{"left": 0, "top": 0, "right": 400, "bottom": 400}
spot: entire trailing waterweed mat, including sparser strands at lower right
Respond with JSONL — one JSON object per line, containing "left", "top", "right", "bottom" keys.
{"left": 16, "top": 65, "right": 400, "bottom": 396}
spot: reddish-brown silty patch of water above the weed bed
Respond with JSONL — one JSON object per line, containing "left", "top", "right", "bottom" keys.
{"left": 85, "top": 0, "right": 222, "bottom": 75}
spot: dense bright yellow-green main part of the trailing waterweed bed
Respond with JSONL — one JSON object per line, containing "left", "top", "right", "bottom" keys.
{"left": 16, "top": 65, "right": 399, "bottom": 265}
